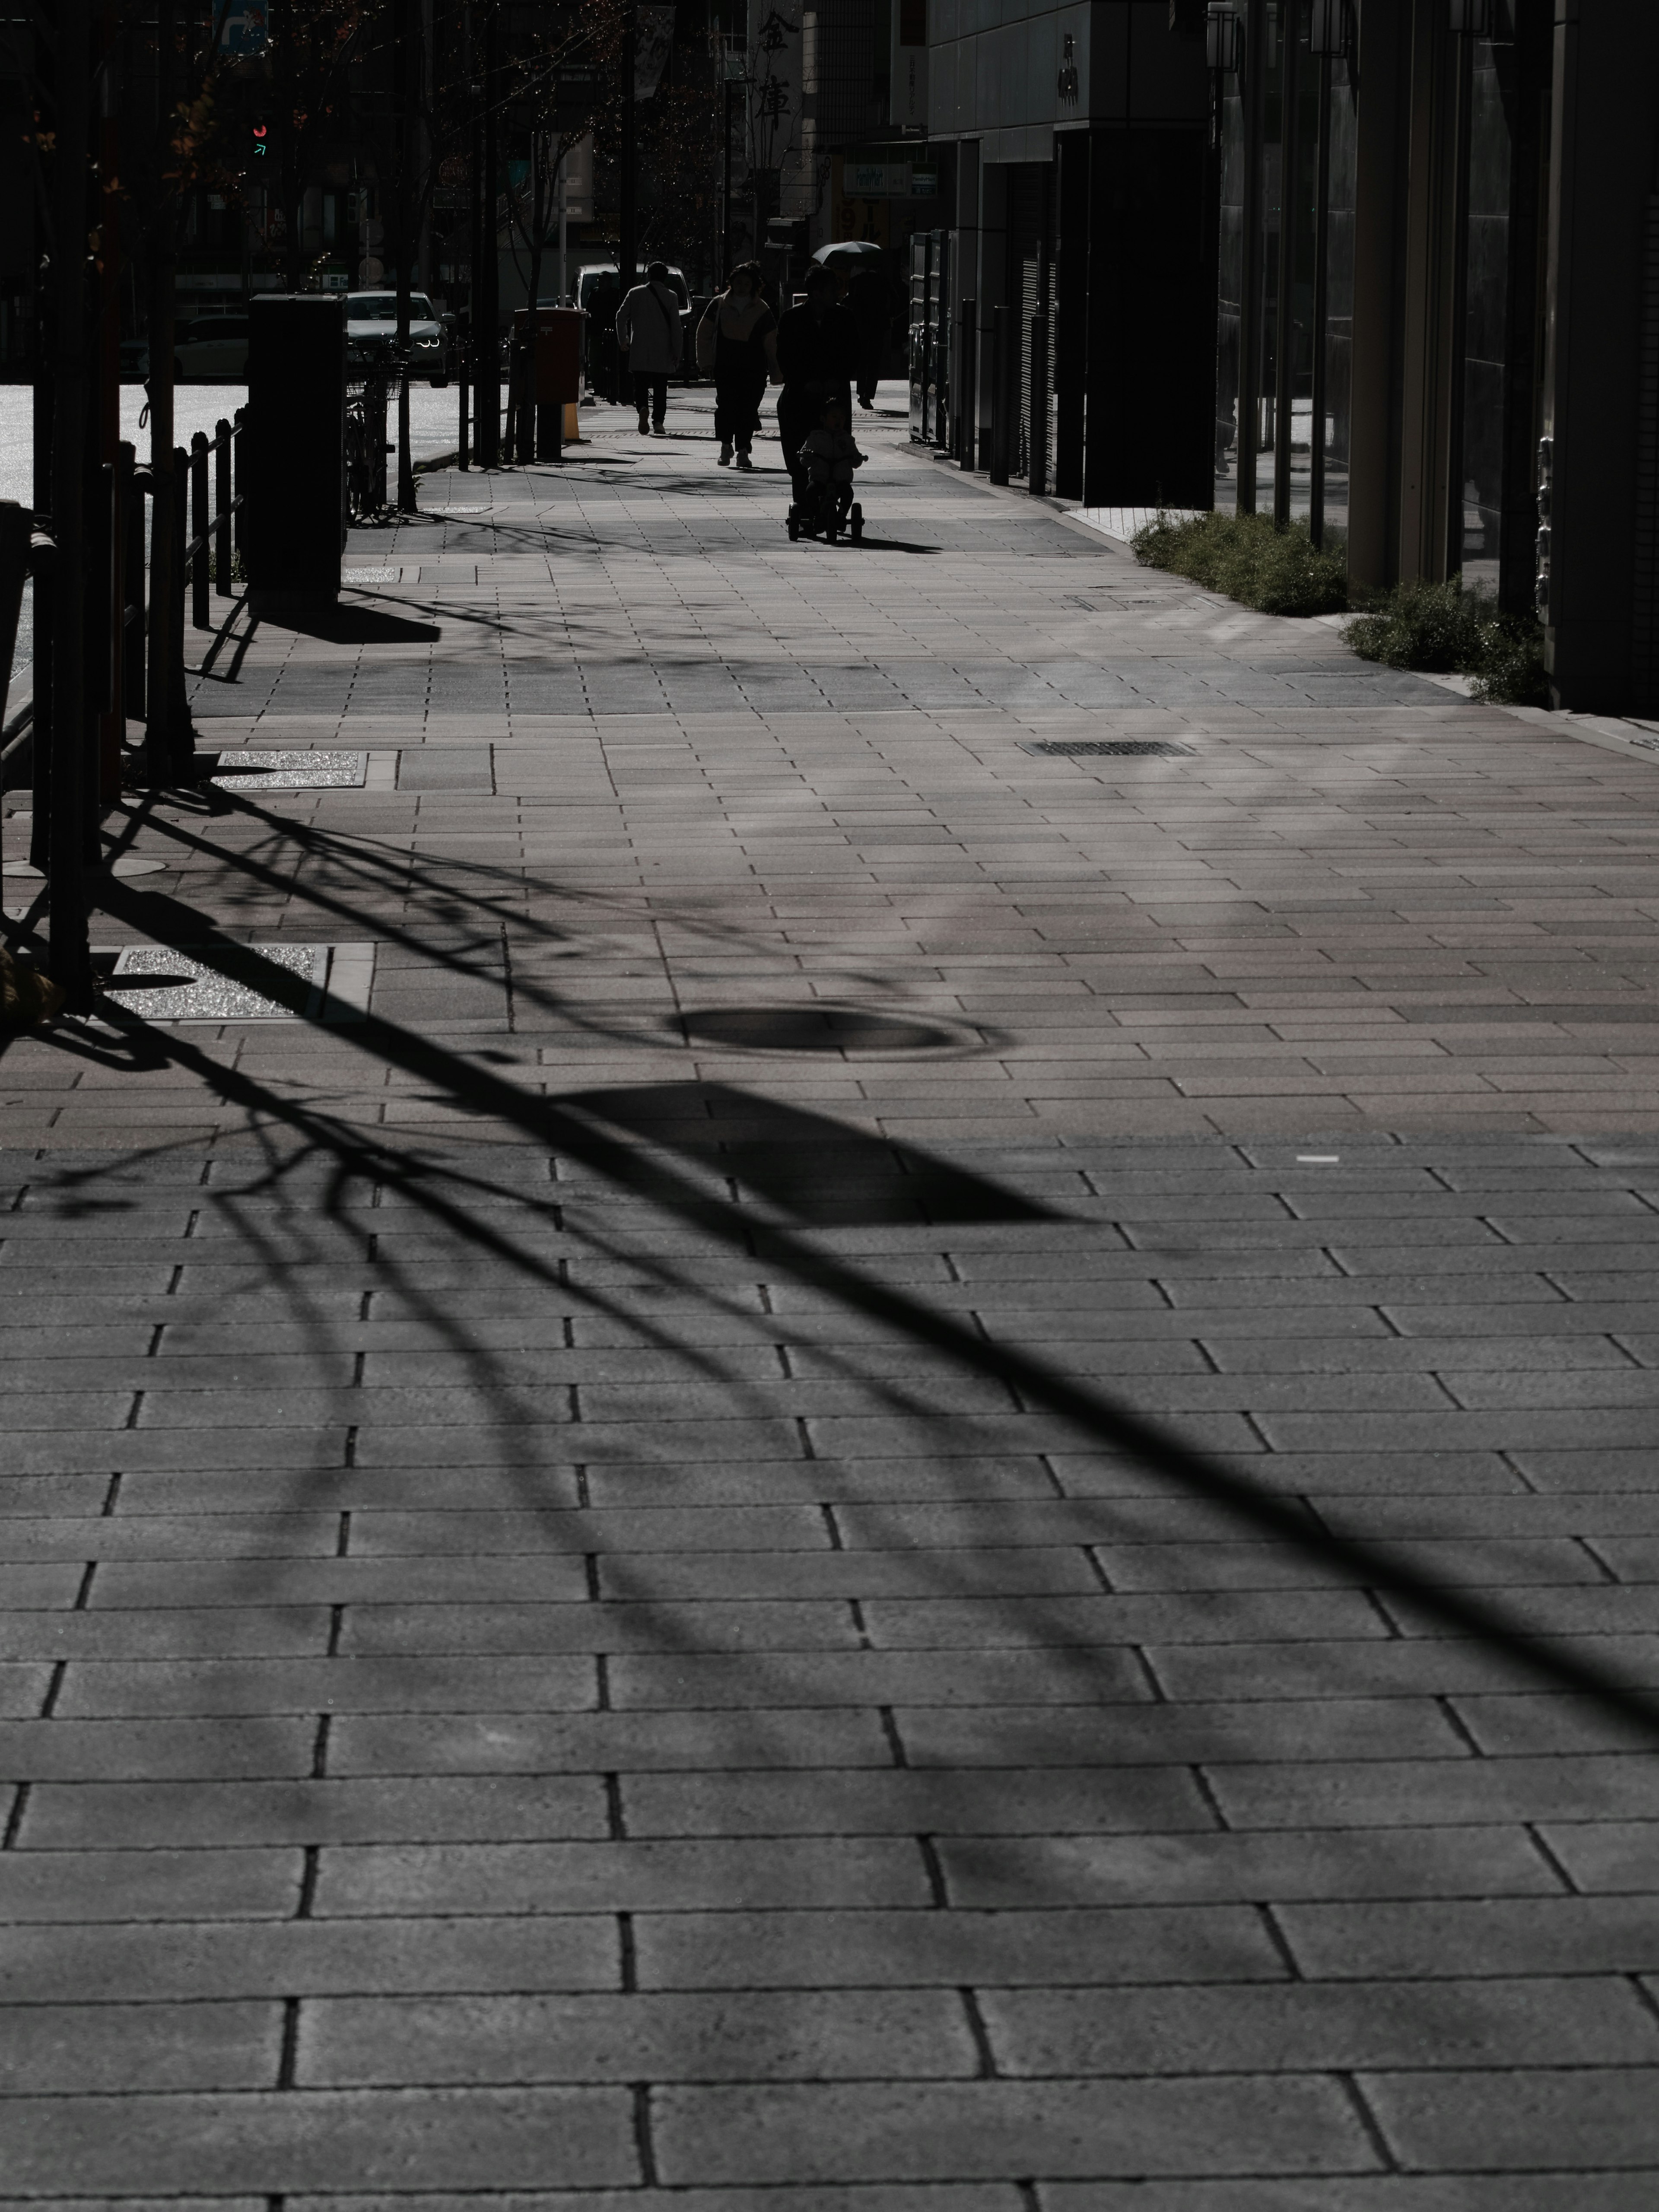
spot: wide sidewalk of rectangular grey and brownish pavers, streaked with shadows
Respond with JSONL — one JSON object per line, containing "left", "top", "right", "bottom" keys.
{"left": 0, "top": 398, "right": 1659, "bottom": 2212}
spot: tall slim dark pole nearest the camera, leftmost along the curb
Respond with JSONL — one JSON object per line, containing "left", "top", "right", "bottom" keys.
{"left": 44, "top": 0, "right": 93, "bottom": 1013}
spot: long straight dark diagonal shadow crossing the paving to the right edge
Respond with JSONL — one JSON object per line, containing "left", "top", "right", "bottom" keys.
{"left": 81, "top": 880, "right": 1659, "bottom": 1736}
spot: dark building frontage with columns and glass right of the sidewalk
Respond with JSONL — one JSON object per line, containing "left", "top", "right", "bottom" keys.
{"left": 927, "top": 0, "right": 1659, "bottom": 715}
